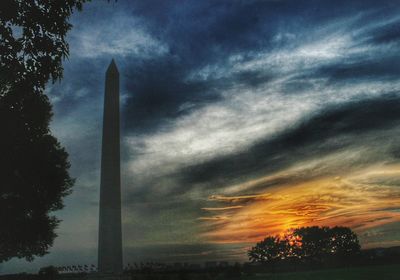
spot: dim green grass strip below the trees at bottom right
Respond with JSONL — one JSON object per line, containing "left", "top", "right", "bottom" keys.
{"left": 242, "top": 264, "right": 400, "bottom": 280}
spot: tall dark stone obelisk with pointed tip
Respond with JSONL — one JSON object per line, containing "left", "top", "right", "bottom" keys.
{"left": 98, "top": 60, "right": 122, "bottom": 274}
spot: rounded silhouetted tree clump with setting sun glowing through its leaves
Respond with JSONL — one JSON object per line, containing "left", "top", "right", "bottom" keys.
{"left": 248, "top": 226, "right": 360, "bottom": 263}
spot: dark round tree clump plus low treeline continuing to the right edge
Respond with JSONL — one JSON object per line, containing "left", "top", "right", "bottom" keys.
{"left": 248, "top": 226, "right": 400, "bottom": 272}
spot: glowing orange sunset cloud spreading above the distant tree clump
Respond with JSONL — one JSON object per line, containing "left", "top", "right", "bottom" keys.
{"left": 201, "top": 166, "right": 400, "bottom": 246}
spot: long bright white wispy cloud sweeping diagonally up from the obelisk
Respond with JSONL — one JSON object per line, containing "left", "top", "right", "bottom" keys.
{"left": 126, "top": 10, "right": 400, "bottom": 190}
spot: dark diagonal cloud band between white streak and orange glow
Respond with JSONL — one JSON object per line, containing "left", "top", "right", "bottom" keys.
{"left": 183, "top": 94, "right": 400, "bottom": 188}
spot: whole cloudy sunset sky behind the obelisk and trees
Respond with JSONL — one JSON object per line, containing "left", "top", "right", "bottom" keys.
{"left": 0, "top": 0, "right": 400, "bottom": 272}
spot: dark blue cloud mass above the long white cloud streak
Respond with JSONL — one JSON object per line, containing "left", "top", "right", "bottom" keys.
{"left": 124, "top": 1, "right": 399, "bottom": 136}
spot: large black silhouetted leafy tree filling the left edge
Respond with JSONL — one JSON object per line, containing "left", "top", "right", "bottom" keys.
{"left": 0, "top": 0, "right": 93, "bottom": 262}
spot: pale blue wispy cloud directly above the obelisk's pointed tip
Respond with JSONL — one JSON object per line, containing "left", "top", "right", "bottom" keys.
{"left": 69, "top": 3, "right": 168, "bottom": 59}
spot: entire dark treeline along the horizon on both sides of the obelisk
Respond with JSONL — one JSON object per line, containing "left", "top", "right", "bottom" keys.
{"left": 0, "top": 226, "right": 400, "bottom": 280}
